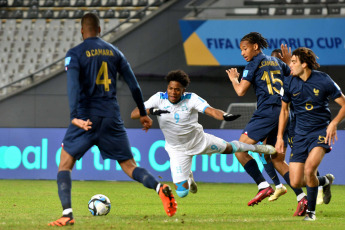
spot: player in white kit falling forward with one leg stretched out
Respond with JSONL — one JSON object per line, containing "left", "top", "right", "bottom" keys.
{"left": 131, "top": 70, "right": 276, "bottom": 197}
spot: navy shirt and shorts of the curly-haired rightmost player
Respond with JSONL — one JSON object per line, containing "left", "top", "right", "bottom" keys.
{"left": 282, "top": 70, "right": 342, "bottom": 163}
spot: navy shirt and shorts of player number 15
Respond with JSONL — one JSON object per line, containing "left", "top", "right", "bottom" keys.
{"left": 242, "top": 53, "right": 290, "bottom": 145}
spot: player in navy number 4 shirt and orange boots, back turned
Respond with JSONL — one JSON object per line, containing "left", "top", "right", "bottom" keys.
{"left": 48, "top": 13, "right": 177, "bottom": 226}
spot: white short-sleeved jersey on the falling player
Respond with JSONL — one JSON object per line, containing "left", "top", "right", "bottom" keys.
{"left": 145, "top": 92, "right": 210, "bottom": 149}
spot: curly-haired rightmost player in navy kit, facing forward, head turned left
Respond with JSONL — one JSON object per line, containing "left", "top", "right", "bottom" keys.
{"left": 276, "top": 47, "right": 345, "bottom": 221}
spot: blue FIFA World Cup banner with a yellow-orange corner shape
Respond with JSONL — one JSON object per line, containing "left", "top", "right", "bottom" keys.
{"left": 180, "top": 18, "right": 345, "bottom": 66}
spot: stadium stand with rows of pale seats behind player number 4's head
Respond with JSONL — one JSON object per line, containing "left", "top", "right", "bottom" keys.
{"left": 0, "top": 0, "right": 166, "bottom": 96}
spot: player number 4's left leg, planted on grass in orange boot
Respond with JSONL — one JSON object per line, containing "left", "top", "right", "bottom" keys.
{"left": 48, "top": 148, "right": 76, "bottom": 226}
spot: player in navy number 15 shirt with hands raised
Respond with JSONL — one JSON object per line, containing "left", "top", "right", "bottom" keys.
{"left": 226, "top": 32, "right": 306, "bottom": 216}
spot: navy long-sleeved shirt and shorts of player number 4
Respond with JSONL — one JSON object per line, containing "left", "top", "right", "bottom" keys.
{"left": 63, "top": 37, "right": 146, "bottom": 161}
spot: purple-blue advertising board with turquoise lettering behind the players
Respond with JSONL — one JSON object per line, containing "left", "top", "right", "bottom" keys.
{"left": 0, "top": 128, "right": 345, "bottom": 184}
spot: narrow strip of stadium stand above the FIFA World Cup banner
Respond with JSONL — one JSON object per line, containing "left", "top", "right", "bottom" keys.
{"left": 187, "top": 0, "right": 345, "bottom": 18}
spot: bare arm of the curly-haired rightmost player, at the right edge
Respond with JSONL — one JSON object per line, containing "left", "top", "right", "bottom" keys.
{"left": 325, "top": 94, "right": 345, "bottom": 145}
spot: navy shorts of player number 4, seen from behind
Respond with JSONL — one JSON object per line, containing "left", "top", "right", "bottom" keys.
{"left": 63, "top": 116, "right": 133, "bottom": 161}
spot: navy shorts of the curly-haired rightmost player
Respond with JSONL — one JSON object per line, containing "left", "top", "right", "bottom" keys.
{"left": 290, "top": 128, "right": 332, "bottom": 163}
